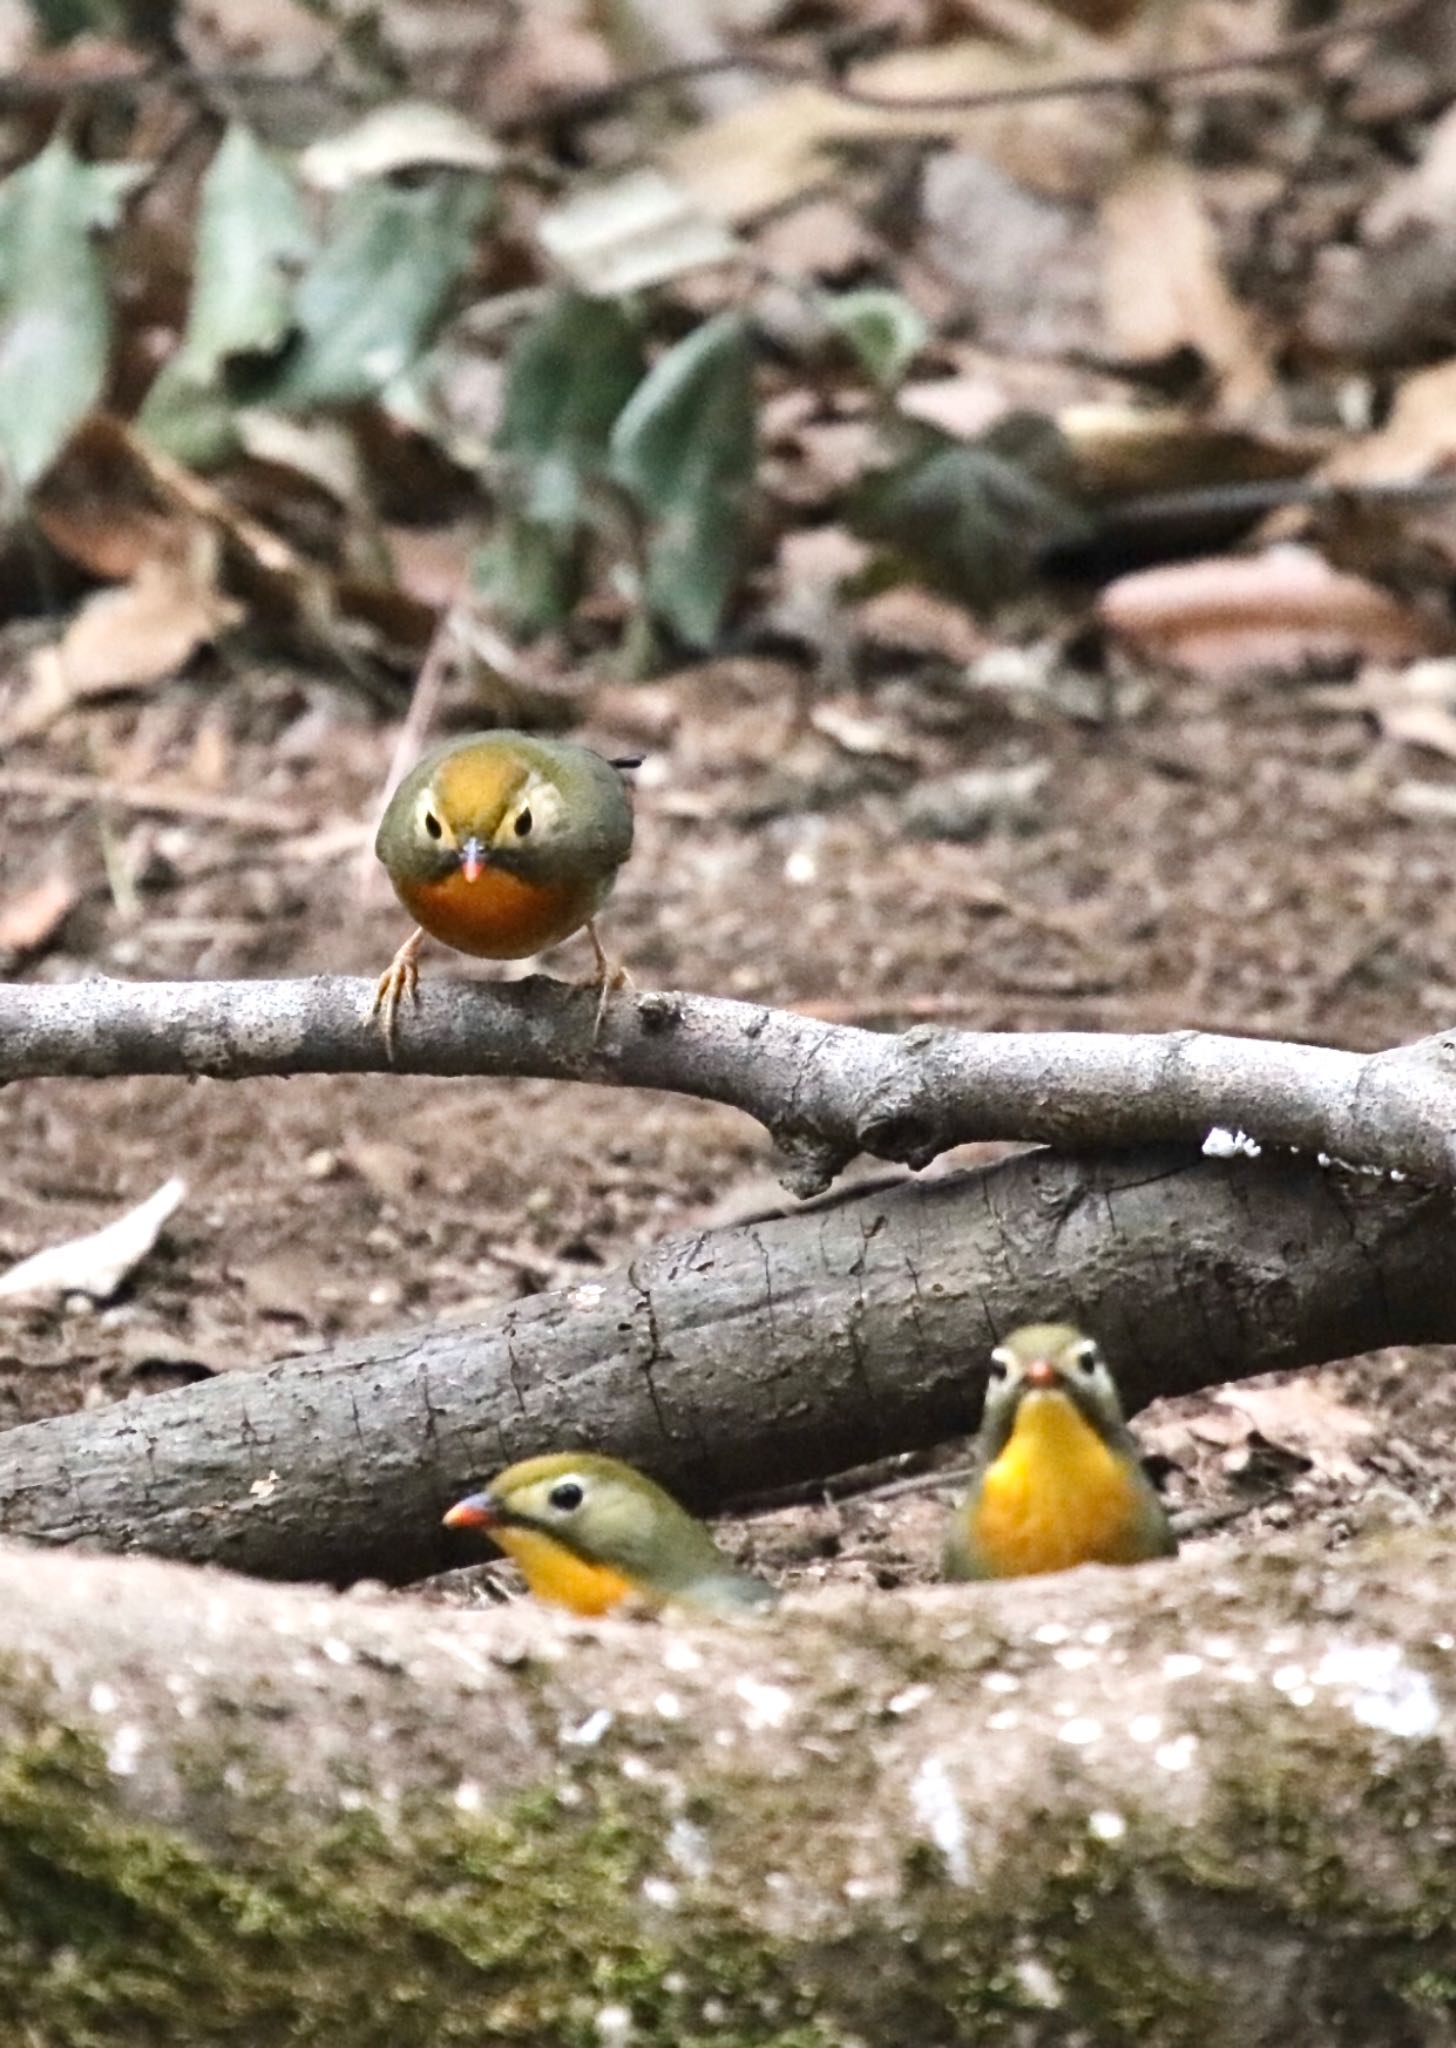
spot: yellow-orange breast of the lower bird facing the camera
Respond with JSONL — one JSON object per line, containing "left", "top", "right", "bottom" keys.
{"left": 967, "top": 1389, "right": 1141, "bottom": 1579}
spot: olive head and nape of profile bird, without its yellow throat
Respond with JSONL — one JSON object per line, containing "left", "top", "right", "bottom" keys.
{"left": 444, "top": 1450, "right": 772, "bottom": 1606}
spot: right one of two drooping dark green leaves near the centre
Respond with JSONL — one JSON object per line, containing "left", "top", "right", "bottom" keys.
{"left": 612, "top": 313, "right": 756, "bottom": 647}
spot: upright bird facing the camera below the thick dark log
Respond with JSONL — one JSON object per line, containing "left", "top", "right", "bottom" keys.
{"left": 944, "top": 1323, "right": 1177, "bottom": 1579}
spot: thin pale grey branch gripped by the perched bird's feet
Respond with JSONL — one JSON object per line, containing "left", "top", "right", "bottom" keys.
{"left": 0, "top": 977, "right": 1456, "bottom": 1194}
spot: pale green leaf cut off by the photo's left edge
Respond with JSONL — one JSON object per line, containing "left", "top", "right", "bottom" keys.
{"left": 0, "top": 135, "right": 132, "bottom": 492}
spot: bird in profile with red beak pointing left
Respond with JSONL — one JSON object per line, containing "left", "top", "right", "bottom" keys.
{"left": 444, "top": 1450, "right": 778, "bottom": 1616}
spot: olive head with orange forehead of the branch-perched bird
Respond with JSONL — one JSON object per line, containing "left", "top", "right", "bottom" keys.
{"left": 375, "top": 731, "right": 633, "bottom": 883}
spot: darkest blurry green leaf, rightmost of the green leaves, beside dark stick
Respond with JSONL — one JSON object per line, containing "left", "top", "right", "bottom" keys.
{"left": 850, "top": 414, "right": 1087, "bottom": 610}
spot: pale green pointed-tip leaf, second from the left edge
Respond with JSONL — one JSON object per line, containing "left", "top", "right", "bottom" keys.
{"left": 139, "top": 121, "right": 313, "bottom": 469}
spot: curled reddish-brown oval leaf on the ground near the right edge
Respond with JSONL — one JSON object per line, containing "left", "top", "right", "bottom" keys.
{"left": 1098, "top": 547, "right": 1438, "bottom": 676}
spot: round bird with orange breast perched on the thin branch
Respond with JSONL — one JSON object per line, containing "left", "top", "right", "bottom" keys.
{"left": 375, "top": 731, "right": 637, "bottom": 1055}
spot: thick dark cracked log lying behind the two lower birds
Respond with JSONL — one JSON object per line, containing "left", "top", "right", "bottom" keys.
{"left": 0, "top": 1151, "right": 1456, "bottom": 1581}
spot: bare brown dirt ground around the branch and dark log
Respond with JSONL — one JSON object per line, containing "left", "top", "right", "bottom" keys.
{"left": 0, "top": 657, "right": 1456, "bottom": 1597}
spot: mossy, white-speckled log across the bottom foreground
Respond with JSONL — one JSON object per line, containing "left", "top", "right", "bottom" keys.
{"left": 0, "top": 1532, "right": 1456, "bottom": 2048}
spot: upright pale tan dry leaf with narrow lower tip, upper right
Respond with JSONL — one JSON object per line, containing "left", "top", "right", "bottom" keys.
{"left": 1102, "top": 156, "right": 1274, "bottom": 414}
